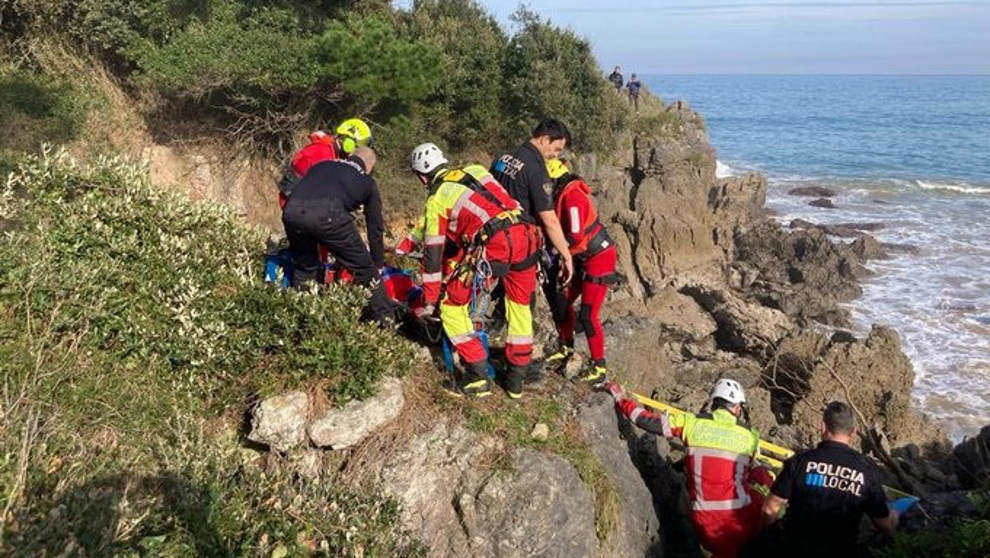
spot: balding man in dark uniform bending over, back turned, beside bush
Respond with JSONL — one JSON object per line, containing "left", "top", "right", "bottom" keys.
{"left": 282, "top": 147, "right": 391, "bottom": 323}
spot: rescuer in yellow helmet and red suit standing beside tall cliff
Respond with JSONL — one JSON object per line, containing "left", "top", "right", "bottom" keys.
{"left": 547, "top": 159, "right": 618, "bottom": 382}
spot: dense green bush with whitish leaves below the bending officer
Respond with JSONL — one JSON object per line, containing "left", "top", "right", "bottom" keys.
{"left": 0, "top": 147, "right": 411, "bottom": 403}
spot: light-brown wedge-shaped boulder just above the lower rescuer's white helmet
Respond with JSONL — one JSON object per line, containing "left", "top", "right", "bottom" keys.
{"left": 681, "top": 285, "right": 794, "bottom": 355}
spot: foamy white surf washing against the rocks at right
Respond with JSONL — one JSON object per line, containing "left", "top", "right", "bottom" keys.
{"left": 767, "top": 177, "right": 990, "bottom": 440}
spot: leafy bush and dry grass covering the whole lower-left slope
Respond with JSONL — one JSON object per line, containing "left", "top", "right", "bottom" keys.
{"left": 0, "top": 149, "right": 422, "bottom": 556}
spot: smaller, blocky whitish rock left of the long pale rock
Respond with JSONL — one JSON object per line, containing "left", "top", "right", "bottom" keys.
{"left": 247, "top": 391, "right": 309, "bottom": 451}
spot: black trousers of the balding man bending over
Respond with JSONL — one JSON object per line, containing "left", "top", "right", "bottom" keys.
{"left": 282, "top": 198, "right": 391, "bottom": 321}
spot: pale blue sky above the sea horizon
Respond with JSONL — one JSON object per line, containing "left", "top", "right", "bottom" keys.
{"left": 397, "top": 0, "right": 990, "bottom": 76}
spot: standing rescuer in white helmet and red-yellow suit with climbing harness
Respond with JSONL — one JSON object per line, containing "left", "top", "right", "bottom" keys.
{"left": 410, "top": 143, "right": 541, "bottom": 399}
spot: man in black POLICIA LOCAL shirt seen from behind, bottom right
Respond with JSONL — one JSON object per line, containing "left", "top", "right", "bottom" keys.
{"left": 763, "top": 401, "right": 898, "bottom": 558}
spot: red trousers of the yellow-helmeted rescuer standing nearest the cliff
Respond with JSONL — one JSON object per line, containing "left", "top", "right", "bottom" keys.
{"left": 557, "top": 246, "right": 618, "bottom": 360}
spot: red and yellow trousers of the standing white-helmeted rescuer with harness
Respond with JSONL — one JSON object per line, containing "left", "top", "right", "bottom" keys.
{"left": 440, "top": 223, "right": 540, "bottom": 366}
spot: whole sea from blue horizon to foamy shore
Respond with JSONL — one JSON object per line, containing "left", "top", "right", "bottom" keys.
{"left": 644, "top": 75, "right": 990, "bottom": 439}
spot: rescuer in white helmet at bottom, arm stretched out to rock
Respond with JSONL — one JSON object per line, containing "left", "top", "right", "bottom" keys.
{"left": 605, "top": 378, "right": 773, "bottom": 558}
